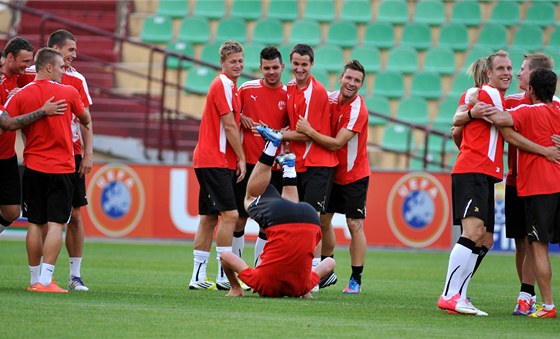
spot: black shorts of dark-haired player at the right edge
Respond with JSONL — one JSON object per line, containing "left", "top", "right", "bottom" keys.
{"left": 523, "top": 193, "right": 560, "bottom": 243}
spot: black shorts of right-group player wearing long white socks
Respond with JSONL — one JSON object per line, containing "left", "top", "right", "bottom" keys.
{"left": 451, "top": 173, "right": 494, "bottom": 233}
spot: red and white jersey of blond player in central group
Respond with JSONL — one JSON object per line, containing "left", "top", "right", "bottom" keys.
{"left": 193, "top": 73, "right": 241, "bottom": 169}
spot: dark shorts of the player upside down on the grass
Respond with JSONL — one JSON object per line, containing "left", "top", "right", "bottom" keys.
{"left": 247, "top": 185, "right": 320, "bottom": 228}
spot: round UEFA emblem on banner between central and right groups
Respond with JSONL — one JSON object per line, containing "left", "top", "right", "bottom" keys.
{"left": 387, "top": 172, "right": 449, "bottom": 248}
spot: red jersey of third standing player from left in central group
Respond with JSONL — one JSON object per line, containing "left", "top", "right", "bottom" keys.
{"left": 287, "top": 76, "right": 338, "bottom": 172}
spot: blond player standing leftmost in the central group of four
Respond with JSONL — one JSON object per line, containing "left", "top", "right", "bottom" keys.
{"left": 189, "top": 40, "right": 246, "bottom": 290}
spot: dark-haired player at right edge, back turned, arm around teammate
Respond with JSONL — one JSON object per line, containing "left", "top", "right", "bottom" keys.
{"left": 488, "top": 69, "right": 560, "bottom": 318}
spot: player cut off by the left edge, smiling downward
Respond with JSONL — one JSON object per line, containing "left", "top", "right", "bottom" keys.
{"left": 0, "top": 37, "right": 33, "bottom": 233}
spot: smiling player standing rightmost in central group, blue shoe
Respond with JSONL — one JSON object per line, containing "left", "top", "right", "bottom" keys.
{"left": 296, "top": 60, "right": 371, "bottom": 294}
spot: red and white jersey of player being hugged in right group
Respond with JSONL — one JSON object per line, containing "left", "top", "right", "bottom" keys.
{"left": 452, "top": 85, "right": 504, "bottom": 182}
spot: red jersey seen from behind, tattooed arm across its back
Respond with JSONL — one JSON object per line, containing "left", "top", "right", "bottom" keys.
{"left": 6, "top": 80, "right": 84, "bottom": 174}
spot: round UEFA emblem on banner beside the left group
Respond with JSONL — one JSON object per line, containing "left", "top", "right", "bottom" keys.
{"left": 87, "top": 164, "right": 145, "bottom": 237}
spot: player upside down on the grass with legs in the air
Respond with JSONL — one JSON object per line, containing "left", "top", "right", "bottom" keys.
{"left": 221, "top": 126, "right": 335, "bottom": 298}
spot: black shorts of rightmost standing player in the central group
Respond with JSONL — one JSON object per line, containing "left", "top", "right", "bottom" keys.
{"left": 327, "top": 177, "right": 369, "bottom": 219}
